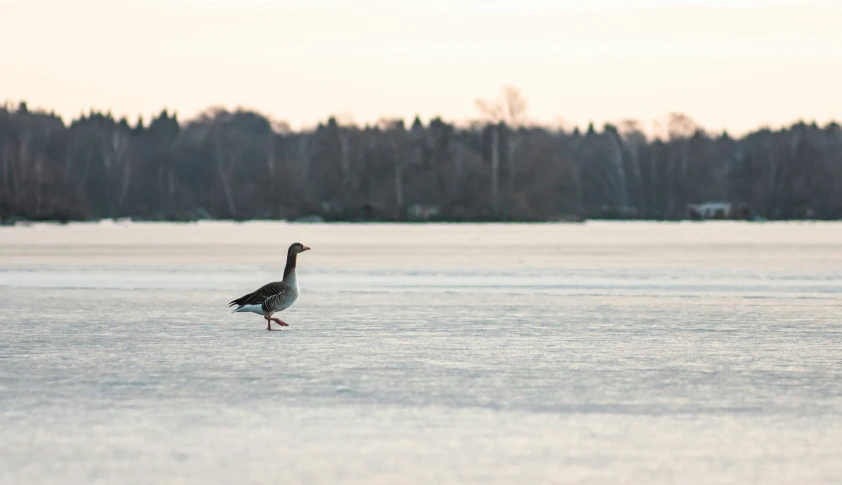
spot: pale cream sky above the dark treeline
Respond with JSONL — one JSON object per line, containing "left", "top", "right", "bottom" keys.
{"left": 0, "top": 0, "right": 842, "bottom": 134}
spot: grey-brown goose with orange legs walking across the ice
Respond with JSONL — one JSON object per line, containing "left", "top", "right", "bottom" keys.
{"left": 228, "top": 243, "right": 310, "bottom": 331}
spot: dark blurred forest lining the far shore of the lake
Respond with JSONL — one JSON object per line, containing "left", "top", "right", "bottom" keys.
{"left": 0, "top": 88, "right": 842, "bottom": 223}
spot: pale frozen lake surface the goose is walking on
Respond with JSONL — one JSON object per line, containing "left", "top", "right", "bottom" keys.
{"left": 0, "top": 222, "right": 842, "bottom": 485}
